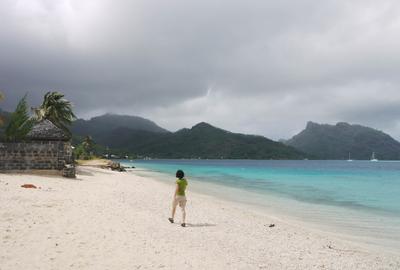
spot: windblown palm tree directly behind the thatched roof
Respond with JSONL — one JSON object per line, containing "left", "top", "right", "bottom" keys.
{"left": 32, "top": 92, "right": 76, "bottom": 133}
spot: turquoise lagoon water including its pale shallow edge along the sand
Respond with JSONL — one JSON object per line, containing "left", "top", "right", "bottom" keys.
{"left": 121, "top": 160, "right": 400, "bottom": 248}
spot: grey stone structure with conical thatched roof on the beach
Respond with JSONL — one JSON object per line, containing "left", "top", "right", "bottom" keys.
{"left": 0, "top": 120, "right": 75, "bottom": 177}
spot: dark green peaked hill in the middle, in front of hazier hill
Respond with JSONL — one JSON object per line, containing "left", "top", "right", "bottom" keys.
{"left": 93, "top": 123, "right": 305, "bottom": 159}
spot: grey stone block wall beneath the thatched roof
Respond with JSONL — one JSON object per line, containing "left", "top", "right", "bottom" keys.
{"left": 0, "top": 141, "right": 73, "bottom": 171}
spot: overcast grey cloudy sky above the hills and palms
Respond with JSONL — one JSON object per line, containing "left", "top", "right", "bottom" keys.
{"left": 0, "top": 0, "right": 400, "bottom": 139}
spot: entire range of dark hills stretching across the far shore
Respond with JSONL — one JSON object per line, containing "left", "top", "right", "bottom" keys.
{"left": 0, "top": 109, "right": 400, "bottom": 160}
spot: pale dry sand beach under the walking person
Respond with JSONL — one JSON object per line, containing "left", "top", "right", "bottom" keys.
{"left": 0, "top": 167, "right": 400, "bottom": 270}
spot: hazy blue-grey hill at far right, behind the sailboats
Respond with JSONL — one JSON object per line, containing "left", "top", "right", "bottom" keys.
{"left": 286, "top": 122, "right": 400, "bottom": 160}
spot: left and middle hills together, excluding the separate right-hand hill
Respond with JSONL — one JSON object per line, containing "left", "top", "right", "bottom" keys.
{"left": 72, "top": 115, "right": 305, "bottom": 159}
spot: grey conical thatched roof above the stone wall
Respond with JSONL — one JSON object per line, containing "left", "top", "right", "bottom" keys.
{"left": 27, "top": 120, "right": 71, "bottom": 141}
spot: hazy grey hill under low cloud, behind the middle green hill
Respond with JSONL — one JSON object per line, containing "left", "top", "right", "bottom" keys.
{"left": 71, "top": 114, "right": 169, "bottom": 140}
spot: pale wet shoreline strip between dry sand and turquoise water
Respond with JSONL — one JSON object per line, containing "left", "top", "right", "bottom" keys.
{"left": 127, "top": 166, "right": 400, "bottom": 253}
